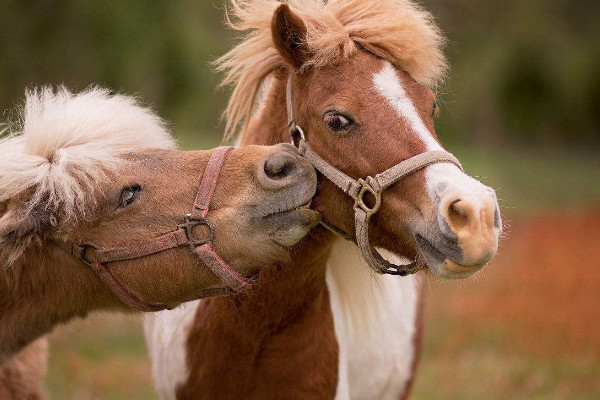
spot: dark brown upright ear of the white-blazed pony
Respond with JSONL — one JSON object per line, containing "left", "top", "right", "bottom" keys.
{"left": 271, "top": 4, "right": 310, "bottom": 71}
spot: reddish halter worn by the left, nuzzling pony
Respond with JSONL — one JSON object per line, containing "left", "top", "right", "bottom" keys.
{"left": 71, "top": 146, "right": 252, "bottom": 312}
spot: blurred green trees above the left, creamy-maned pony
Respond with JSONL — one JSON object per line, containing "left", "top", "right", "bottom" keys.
{"left": 0, "top": 0, "right": 232, "bottom": 144}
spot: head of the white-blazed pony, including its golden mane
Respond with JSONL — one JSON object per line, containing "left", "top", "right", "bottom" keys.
{"left": 219, "top": 0, "right": 501, "bottom": 278}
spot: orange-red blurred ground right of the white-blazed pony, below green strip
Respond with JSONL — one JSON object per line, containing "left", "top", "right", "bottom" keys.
{"left": 414, "top": 208, "right": 600, "bottom": 400}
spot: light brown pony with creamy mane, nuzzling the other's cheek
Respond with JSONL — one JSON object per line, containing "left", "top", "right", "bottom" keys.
{"left": 0, "top": 88, "right": 319, "bottom": 398}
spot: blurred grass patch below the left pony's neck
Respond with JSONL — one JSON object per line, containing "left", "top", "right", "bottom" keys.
{"left": 46, "top": 314, "right": 156, "bottom": 400}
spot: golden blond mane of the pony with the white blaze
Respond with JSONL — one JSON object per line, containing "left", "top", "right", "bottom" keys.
{"left": 216, "top": 0, "right": 447, "bottom": 137}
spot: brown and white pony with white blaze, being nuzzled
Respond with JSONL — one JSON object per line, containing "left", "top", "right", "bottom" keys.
{"left": 146, "top": 0, "right": 501, "bottom": 400}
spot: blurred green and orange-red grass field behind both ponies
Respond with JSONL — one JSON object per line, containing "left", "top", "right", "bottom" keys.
{"left": 47, "top": 143, "right": 600, "bottom": 400}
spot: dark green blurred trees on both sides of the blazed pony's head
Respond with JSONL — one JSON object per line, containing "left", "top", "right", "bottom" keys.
{"left": 0, "top": 0, "right": 600, "bottom": 148}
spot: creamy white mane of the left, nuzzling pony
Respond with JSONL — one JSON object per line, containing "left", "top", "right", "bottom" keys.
{"left": 0, "top": 87, "right": 174, "bottom": 225}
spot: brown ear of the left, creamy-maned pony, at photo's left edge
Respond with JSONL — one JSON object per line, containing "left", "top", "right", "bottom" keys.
{"left": 0, "top": 204, "right": 57, "bottom": 266}
